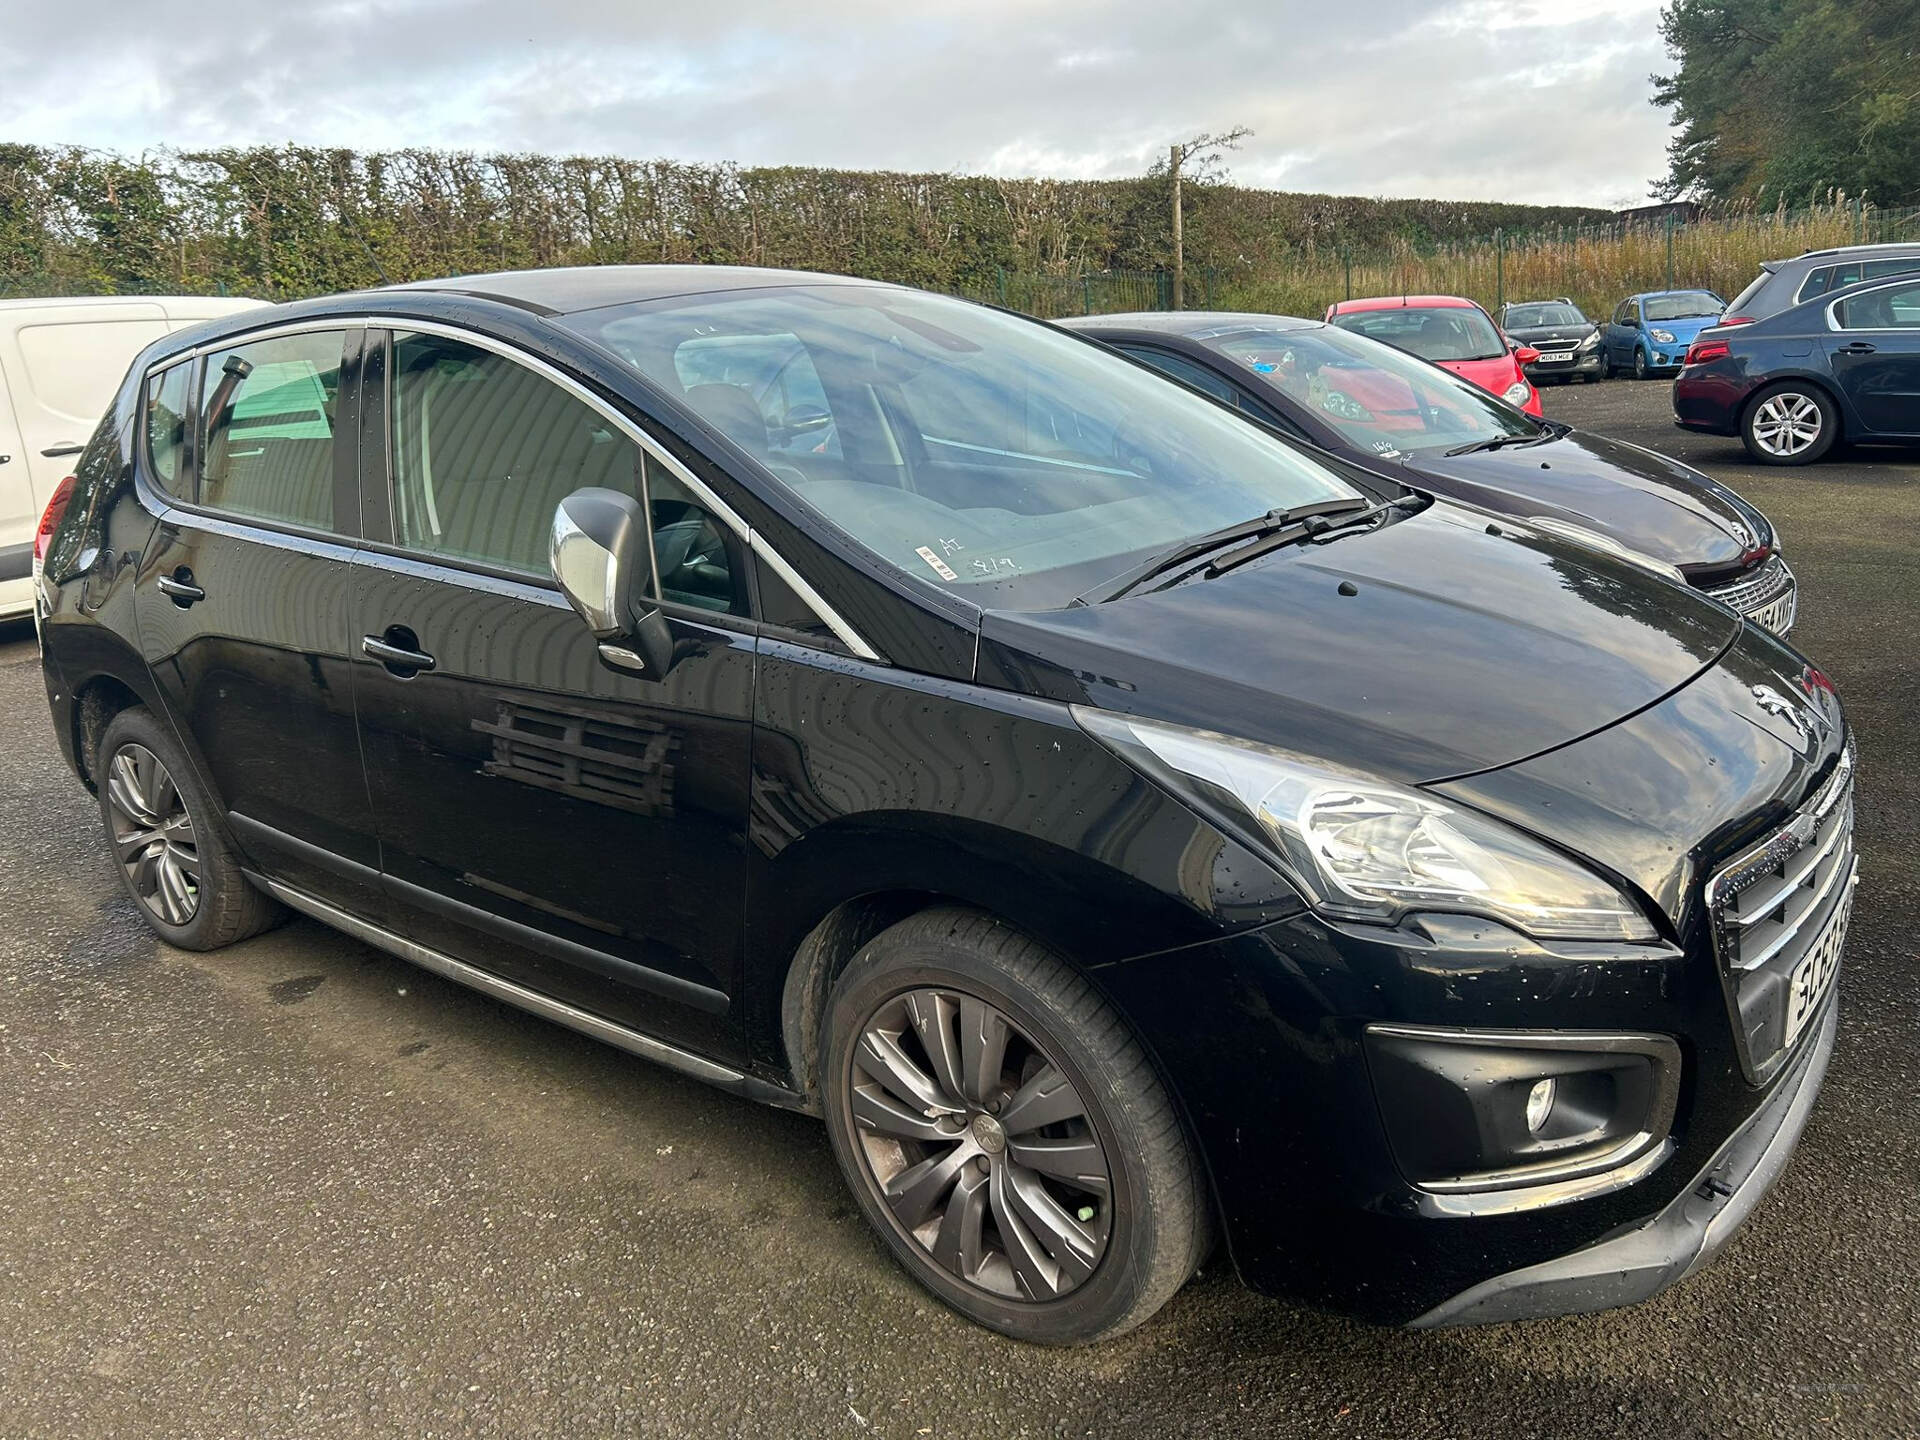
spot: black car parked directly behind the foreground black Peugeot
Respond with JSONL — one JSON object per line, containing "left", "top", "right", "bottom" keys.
{"left": 1064, "top": 311, "right": 1799, "bottom": 636}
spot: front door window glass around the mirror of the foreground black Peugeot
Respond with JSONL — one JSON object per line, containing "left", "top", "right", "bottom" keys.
{"left": 392, "top": 334, "right": 747, "bottom": 614}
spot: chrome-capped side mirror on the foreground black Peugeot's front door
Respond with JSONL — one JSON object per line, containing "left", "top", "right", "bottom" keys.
{"left": 547, "top": 490, "right": 674, "bottom": 680}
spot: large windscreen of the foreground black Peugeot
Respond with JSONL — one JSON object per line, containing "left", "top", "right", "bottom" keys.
{"left": 563, "top": 284, "right": 1359, "bottom": 609}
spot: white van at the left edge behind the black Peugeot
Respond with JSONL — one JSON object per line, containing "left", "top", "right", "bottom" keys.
{"left": 0, "top": 296, "right": 261, "bottom": 620}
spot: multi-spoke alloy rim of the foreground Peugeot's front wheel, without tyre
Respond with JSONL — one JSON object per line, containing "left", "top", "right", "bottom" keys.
{"left": 847, "top": 989, "right": 1114, "bottom": 1302}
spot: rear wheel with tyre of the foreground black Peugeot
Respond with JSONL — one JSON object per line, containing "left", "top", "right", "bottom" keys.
{"left": 94, "top": 707, "right": 284, "bottom": 950}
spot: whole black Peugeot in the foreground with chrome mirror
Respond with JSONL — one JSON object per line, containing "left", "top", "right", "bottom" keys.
{"left": 38, "top": 267, "right": 1855, "bottom": 1342}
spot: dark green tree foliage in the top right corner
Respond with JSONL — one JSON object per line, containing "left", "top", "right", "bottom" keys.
{"left": 1653, "top": 0, "right": 1920, "bottom": 204}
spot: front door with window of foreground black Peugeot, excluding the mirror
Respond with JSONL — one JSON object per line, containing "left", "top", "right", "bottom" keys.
{"left": 351, "top": 332, "right": 755, "bottom": 1054}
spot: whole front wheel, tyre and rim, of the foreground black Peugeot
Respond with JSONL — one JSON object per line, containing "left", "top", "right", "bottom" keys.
{"left": 820, "top": 906, "right": 1212, "bottom": 1344}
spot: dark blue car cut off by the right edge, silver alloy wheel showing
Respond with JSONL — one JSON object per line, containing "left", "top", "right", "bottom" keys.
{"left": 1674, "top": 275, "right": 1920, "bottom": 465}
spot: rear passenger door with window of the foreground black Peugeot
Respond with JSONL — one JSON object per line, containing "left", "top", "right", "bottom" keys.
{"left": 134, "top": 326, "right": 386, "bottom": 918}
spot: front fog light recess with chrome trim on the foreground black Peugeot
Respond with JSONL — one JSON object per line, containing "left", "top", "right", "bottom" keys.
{"left": 1367, "top": 1025, "right": 1680, "bottom": 1204}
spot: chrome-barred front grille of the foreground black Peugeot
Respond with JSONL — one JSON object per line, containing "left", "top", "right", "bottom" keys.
{"left": 1707, "top": 743, "right": 1859, "bottom": 1085}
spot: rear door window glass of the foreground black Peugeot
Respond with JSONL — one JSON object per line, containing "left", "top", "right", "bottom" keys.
{"left": 200, "top": 330, "right": 344, "bottom": 530}
